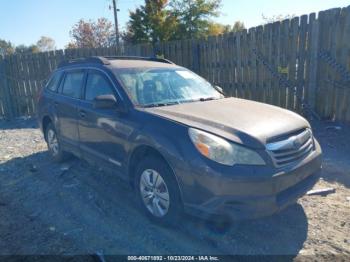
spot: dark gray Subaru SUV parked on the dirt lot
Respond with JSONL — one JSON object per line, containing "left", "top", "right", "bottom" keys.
{"left": 38, "top": 57, "right": 322, "bottom": 223}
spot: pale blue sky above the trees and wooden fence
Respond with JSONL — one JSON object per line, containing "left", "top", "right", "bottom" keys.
{"left": 0, "top": 0, "right": 350, "bottom": 48}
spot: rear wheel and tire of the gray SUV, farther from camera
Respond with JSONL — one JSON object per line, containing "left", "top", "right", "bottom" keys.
{"left": 45, "top": 123, "right": 69, "bottom": 163}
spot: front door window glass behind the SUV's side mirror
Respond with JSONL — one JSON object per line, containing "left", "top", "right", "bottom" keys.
{"left": 85, "top": 73, "right": 114, "bottom": 101}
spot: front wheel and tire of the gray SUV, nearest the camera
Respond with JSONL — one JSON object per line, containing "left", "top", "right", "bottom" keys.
{"left": 135, "top": 156, "right": 183, "bottom": 226}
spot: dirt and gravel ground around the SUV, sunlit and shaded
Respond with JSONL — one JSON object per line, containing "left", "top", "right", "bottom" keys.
{"left": 0, "top": 120, "right": 350, "bottom": 261}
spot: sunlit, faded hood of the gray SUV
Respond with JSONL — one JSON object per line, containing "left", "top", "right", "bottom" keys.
{"left": 144, "top": 98, "right": 310, "bottom": 148}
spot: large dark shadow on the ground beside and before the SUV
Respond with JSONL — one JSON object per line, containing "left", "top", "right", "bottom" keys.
{"left": 0, "top": 152, "right": 308, "bottom": 259}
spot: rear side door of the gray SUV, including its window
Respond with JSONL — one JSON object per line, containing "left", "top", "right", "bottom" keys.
{"left": 54, "top": 69, "right": 86, "bottom": 155}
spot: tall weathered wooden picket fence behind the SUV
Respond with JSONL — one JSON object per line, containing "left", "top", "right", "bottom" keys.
{"left": 0, "top": 6, "right": 350, "bottom": 121}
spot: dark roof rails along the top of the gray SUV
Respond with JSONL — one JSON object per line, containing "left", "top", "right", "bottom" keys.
{"left": 58, "top": 56, "right": 174, "bottom": 68}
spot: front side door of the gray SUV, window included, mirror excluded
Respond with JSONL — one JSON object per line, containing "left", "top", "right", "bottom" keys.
{"left": 79, "top": 69, "right": 131, "bottom": 170}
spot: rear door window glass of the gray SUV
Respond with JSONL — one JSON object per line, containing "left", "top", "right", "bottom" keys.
{"left": 62, "top": 71, "right": 84, "bottom": 98}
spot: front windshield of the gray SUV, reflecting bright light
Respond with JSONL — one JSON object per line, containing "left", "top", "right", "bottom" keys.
{"left": 116, "top": 68, "right": 222, "bottom": 107}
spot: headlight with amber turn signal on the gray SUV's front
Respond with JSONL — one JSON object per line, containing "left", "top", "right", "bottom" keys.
{"left": 188, "top": 128, "right": 265, "bottom": 166}
